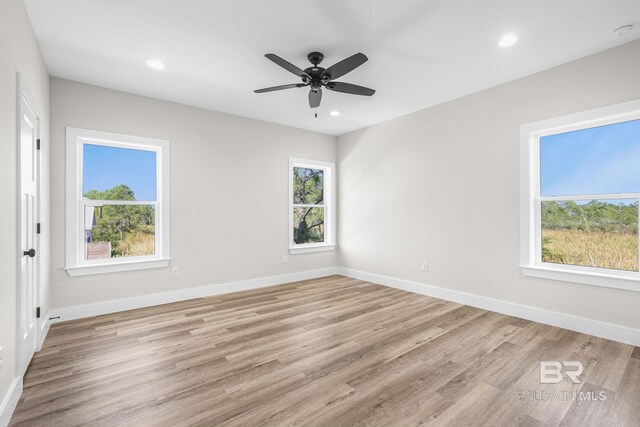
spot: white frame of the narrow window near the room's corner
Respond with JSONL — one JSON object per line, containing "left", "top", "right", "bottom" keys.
{"left": 288, "top": 157, "right": 336, "bottom": 254}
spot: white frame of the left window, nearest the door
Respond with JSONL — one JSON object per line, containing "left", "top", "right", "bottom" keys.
{"left": 65, "top": 127, "right": 171, "bottom": 276}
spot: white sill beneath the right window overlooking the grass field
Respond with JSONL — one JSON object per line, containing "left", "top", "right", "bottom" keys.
{"left": 520, "top": 265, "right": 640, "bottom": 292}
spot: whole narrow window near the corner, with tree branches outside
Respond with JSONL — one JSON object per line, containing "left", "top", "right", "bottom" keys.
{"left": 289, "top": 159, "right": 335, "bottom": 254}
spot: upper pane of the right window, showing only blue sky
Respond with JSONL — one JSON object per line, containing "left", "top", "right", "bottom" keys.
{"left": 540, "top": 120, "right": 640, "bottom": 197}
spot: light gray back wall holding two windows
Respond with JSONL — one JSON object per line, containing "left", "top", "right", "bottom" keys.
{"left": 51, "top": 78, "right": 337, "bottom": 308}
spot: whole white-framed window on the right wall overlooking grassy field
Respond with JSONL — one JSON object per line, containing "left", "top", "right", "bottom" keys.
{"left": 521, "top": 101, "right": 640, "bottom": 291}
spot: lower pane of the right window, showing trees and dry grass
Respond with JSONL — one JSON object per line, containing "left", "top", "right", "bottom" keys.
{"left": 542, "top": 199, "right": 638, "bottom": 271}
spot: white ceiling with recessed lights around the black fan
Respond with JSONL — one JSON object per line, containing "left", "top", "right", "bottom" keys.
{"left": 24, "top": 0, "right": 640, "bottom": 135}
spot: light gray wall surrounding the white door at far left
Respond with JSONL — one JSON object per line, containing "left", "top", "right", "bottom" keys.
{"left": 0, "top": 0, "right": 50, "bottom": 416}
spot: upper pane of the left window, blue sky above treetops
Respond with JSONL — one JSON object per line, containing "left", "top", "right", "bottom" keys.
{"left": 82, "top": 144, "right": 156, "bottom": 201}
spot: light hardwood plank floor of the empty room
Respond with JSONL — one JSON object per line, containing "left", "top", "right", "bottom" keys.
{"left": 11, "top": 276, "right": 640, "bottom": 426}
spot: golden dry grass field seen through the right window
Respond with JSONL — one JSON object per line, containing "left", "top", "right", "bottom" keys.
{"left": 542, "top": 229, "right": 638, "bottom": 271}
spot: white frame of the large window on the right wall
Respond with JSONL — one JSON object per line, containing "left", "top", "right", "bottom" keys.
{"left": 520, "top": 100, "right": 640, "bottom": 291}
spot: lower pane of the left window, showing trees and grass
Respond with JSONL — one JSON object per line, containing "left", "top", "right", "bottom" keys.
{"left": 84, "top": 205, "right": 156, "bottom": 260}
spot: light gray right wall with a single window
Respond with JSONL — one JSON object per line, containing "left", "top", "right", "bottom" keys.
{"left": 338, "top": 42, "right": 640, "bottom": 329}
